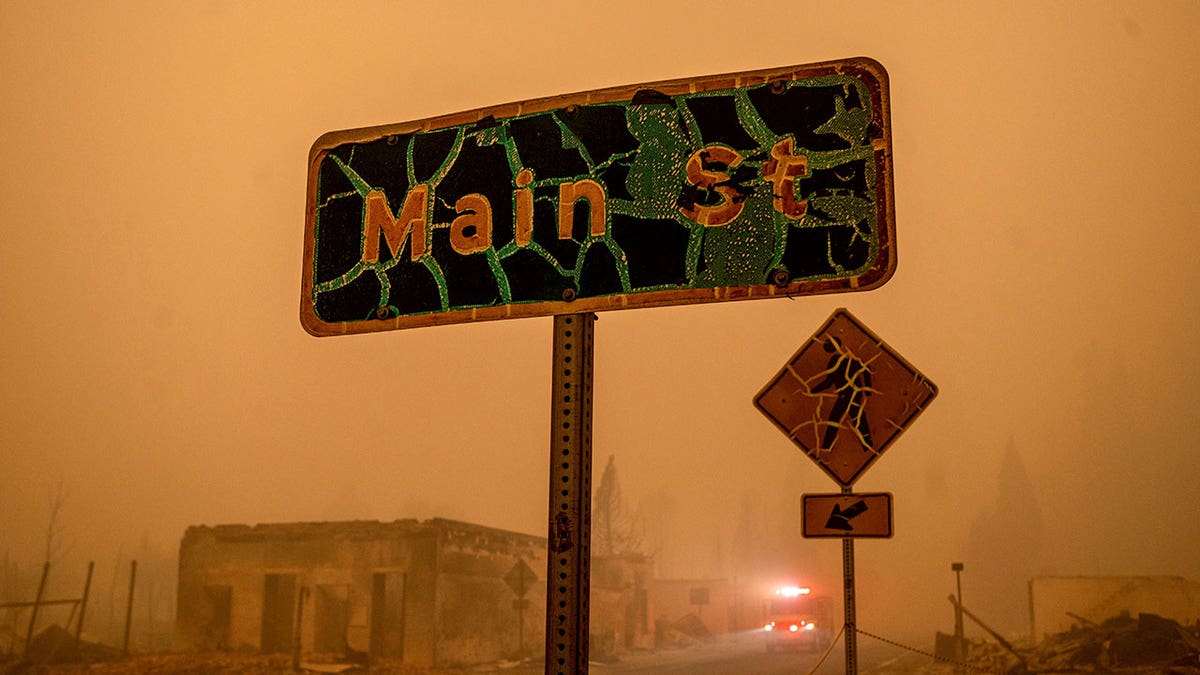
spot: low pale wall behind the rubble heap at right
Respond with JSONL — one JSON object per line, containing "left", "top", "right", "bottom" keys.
{"left": 1030, "top": 577, "right": 1200, "bottom": 640}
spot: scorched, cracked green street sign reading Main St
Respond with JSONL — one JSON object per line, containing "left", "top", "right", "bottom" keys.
{"left": 300, "top": 59, "right": 895, "bottom": 335}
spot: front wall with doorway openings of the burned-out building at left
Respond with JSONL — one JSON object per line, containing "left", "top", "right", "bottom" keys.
{"left": 176, "top": 521, "right": 436, "bottom": 658}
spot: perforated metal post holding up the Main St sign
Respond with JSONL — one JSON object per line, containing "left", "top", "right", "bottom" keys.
{"left": 545, "top": 313, "right": 595, "bottom": 675}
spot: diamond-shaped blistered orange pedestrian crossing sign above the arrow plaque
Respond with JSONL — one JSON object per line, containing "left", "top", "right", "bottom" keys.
{"left": 755, "top": 309, "right": 937, "bottom": 488}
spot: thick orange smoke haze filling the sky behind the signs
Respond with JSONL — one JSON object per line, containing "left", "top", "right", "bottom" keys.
{"left": 0, "top": 1, "right": 1200, "bottom": 638}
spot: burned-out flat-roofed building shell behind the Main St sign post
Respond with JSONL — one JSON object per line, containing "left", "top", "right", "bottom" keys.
{"left": 175, "top": 519, "right": 653, "bottom": 667}
